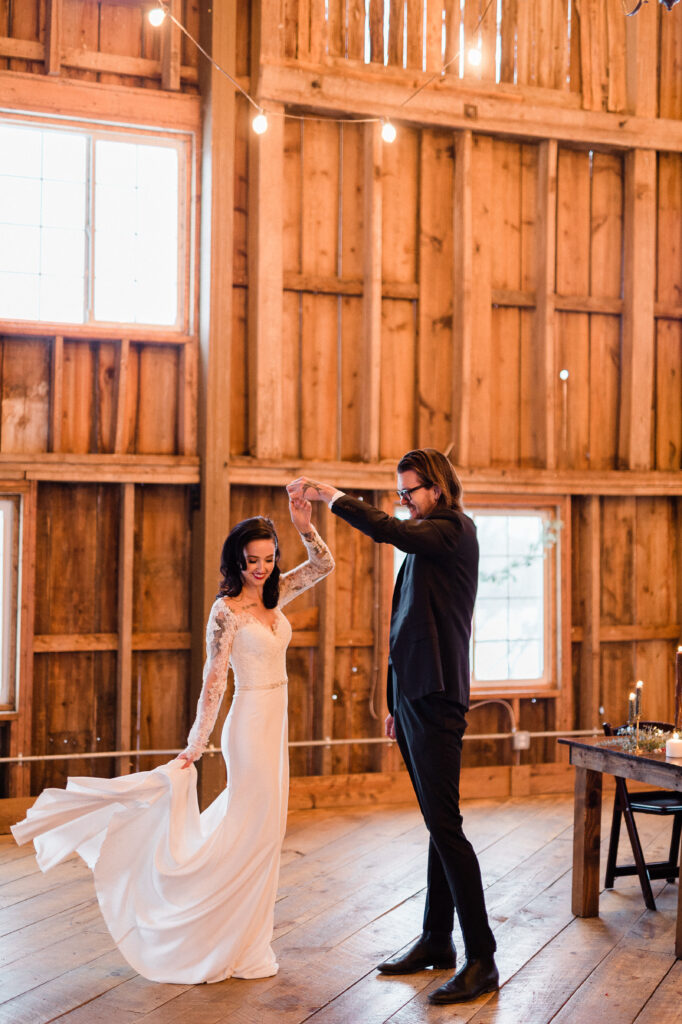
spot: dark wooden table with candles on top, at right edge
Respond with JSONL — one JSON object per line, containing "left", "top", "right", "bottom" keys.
{"left": 559, "top": 739, "right": 682, "bottom": 959}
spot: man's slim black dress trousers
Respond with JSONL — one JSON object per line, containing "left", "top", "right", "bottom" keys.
{"left": 393, "top": 686, "right": 496, "bottom": 957}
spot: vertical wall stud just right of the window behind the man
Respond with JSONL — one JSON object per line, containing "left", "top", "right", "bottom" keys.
{"left": 580, "top": 495, "right": 601, "bottom": 729}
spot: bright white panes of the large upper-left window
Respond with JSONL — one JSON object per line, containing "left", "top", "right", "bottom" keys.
{"left": 0, "top": 121, "right": 186, "bottom": 330}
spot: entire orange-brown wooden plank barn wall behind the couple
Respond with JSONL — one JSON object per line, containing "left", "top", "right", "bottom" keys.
{"left": 0, "top": 0, "right": 682, "bottom": 793}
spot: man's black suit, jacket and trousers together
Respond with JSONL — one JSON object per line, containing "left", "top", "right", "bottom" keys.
{"left": 332, "top": 495, "right": 496, "bottom": 957}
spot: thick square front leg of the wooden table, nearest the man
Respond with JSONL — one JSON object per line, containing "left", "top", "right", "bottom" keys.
{"left": 571, "top": 768, "right": 601, "bottom": 918}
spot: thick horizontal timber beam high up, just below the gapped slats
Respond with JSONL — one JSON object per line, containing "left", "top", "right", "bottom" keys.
{"left": 259, "top": 61, "right": 682, "bottom": 153}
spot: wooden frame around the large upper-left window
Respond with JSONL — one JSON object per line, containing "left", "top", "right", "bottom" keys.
{"left": 0, "top": 109, "right": 193, "bottom": 339}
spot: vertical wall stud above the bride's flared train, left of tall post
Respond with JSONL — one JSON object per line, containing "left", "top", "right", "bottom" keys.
{"left": 116, "top": 483, "right": 135, "bottom": 775}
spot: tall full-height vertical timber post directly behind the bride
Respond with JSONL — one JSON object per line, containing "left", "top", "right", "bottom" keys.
{"left": 195, "top": 0, "right": 237, "bottom": 804}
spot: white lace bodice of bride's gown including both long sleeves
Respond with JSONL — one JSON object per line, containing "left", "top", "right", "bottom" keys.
{"left": 183, "top": 526, "right": 334, "bottom": 759}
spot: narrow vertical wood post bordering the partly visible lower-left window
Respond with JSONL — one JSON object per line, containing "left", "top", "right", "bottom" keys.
{"left": 9, "top": 480, "right": 38, "bottom": 797}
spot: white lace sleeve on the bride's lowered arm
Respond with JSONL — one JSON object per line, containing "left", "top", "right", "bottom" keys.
{"left": 182, "top": 600, "right": 238, "bottom": 760}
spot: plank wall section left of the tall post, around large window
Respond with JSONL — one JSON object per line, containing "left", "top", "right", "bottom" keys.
{"left": 0, "top": 0, "right": 199, "bottom": 795}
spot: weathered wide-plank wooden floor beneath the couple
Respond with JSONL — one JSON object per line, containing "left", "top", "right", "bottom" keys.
{"left": 0, "top": 797, "right": 682, "bottom": 1024}
